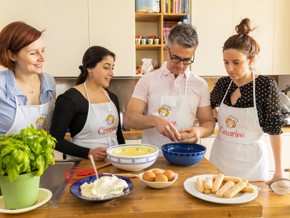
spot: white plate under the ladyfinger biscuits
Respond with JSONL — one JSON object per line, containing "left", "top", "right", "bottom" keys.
{"left": 184, "top": 174, "right": 259, "bottom": 204}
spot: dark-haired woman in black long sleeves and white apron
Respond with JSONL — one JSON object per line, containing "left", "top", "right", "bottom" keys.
{"left": 51, "top": 46, "right": 125, "bottom": 161}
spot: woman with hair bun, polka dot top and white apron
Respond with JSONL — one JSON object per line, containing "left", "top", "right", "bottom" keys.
{"left": 210, "top": 18, "right": 284, "bottom": 182}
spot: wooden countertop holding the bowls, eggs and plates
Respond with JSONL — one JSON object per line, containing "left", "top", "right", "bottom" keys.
{"left": 1, "top": 157, "right": 290, "bottom": 218}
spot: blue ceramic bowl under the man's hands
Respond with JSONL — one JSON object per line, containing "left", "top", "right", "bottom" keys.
{"left": 161, "top": 143, "right": 206, "bottom": 166}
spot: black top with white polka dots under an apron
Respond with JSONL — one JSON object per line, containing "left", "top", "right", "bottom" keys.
{"left": 210, "top": 75, "right": 285, "bottom": 135}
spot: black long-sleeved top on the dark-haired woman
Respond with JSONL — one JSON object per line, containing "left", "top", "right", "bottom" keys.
{"left": 50, "top": 88, "right": 125, "bottom": 158}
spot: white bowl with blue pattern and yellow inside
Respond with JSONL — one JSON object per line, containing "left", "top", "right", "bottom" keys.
{"left": 107, "top": 144, "right": 159, "bottom": 171}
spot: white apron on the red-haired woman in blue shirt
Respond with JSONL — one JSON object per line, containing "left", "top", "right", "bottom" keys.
{"left": 6, "top": 96, "right": 55, "bottom": 135}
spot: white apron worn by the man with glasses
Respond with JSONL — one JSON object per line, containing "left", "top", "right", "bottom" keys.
{"left": 142, "top": 73, "right": 196, "bottom": 148}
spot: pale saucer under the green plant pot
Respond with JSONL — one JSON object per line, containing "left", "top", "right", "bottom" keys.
{"left": 0, "top": 188, "right": 52, "bottom": 214}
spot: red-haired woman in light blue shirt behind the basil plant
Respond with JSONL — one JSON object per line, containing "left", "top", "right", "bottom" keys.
{"left": 0, "top": 22, "right": 55, "bottom": 135}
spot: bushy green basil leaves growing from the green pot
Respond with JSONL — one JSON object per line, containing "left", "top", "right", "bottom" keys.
{"left": 0, "top": 125, "right": 56, "bottom": 180}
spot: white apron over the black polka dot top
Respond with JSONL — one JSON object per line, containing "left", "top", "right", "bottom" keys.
{"left": 209, "top": 75, "right": 269, "bottom": 181}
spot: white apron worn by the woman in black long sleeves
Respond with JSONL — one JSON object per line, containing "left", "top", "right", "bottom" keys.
{"left": 66, "top": 83, "right": 119, "bottom": 158}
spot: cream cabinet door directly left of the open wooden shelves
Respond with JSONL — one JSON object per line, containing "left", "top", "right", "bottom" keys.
{"left": 88, "top": 0, "right": 135, "bottom": 76}
